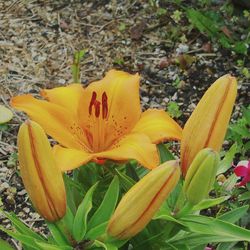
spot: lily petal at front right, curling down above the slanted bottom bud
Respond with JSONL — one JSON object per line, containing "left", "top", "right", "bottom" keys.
{"left": 95, "top": 133, "right": 159, "bottom": 169}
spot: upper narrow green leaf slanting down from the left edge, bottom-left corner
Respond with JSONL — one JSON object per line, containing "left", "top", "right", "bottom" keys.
{"left": 0, "top": 208, "right": 45, "bottom": 242}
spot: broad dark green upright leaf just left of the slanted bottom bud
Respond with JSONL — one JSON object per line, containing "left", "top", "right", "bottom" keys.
{"left": 88, "top": 176, "right": 119, "bottom": 229}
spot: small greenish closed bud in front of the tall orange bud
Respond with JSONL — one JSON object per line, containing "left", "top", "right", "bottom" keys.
{"left": 183, "top": 148, "right": 219, "bottom": 205}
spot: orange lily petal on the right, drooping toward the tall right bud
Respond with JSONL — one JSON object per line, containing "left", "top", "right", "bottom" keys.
{"left": 132, "top": 109, "right": 182, "bottom": 143}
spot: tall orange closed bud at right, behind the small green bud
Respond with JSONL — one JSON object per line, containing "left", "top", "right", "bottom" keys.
{"left": 181, "top": 75, "right": 237, "bottom": 176}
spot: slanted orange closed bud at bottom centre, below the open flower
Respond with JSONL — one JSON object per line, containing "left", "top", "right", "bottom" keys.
{"left": 108, "top": 161, "right": 180, "bottom": 239}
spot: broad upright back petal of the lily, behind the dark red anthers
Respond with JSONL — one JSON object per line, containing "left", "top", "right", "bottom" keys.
{"left": 78, "top": 70, "right": 141, "bottom": 149}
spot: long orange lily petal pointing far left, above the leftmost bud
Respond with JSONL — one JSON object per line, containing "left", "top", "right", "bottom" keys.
{"left": 11, "top": 95, "right": 84, "bottom": 149}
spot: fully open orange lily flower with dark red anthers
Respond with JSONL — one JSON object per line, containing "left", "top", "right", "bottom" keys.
{"left": 11, "top": 70, "right": 182, "bottom": 171}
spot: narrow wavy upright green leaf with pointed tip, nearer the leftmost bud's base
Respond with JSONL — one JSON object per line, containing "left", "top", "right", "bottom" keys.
{"left": 73, "top": 182, "right": 98, "bottom": 241}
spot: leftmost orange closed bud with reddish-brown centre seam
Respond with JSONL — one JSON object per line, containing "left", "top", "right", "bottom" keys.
{"left": 17, "top": 121, "right": 66, "bottom": 221}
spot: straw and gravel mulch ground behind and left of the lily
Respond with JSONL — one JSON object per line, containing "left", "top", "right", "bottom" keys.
{"left": 0, "top": 0, "right": 249, "bottom": 249}
